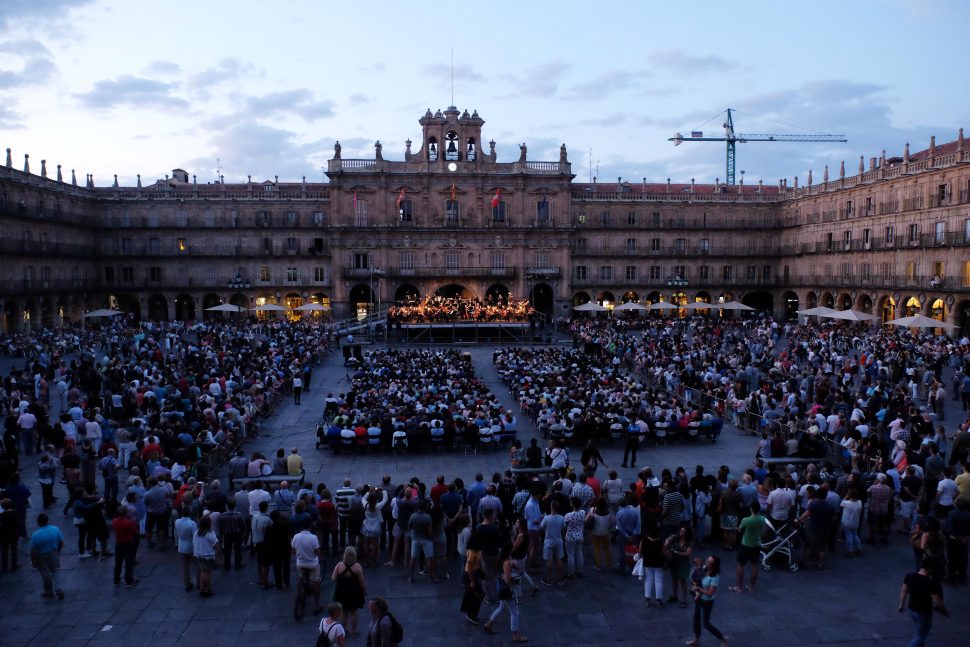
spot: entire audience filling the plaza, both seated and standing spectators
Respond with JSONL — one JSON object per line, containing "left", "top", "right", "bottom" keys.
{"left": 0, "top": 312, "right": 970, "bottom": 647}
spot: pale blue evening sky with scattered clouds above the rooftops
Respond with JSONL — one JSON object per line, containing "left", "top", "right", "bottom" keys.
{"left": 0, "top": 0, "right": 970, "bottom": 185}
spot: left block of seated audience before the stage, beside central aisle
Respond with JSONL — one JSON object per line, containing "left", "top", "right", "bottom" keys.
{"left": 317, "top": 348, "right": 517, "bottom": 452}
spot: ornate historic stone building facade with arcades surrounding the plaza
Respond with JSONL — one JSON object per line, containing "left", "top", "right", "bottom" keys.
{"left": 0, "top": 107, "right": 970, "bottom": 333}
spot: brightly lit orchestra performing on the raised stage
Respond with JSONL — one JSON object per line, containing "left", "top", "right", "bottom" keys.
{"left": 387, "top": 295, "right": 536, "bottom": 325}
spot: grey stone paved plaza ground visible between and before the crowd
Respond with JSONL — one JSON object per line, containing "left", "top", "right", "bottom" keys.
{"left": 0, "top": 347, "right": 970, "bottom": 647}
